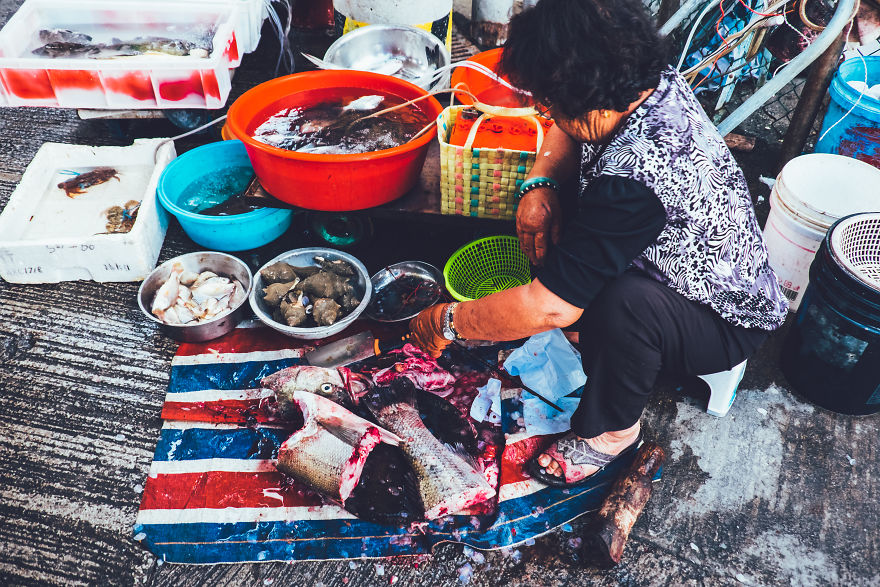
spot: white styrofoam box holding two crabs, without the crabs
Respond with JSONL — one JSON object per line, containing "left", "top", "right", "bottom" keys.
{"left": 0, "top": 139, "right": 176, "bottom": 283}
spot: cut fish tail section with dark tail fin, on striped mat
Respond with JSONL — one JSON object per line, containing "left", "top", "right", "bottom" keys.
{"left": 361, "top": 377, "right": 495, "bottom": 520}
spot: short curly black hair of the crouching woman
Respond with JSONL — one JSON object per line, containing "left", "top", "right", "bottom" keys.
{"left": 501, "top": 0, "right": 667, "bottom": 118}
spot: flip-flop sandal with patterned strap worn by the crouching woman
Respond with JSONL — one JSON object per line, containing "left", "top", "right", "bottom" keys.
{"left": 528, "top": 433, "right": 642, "bottom": 487}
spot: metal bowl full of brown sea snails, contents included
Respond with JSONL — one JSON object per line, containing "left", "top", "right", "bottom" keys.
{"left": 250, "top": 247, "right": 373, "bottom": 340}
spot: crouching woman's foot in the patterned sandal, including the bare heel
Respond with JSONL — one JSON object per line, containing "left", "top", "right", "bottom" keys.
{"left": 537, "top": 422, "right": 641, "bottom": 483}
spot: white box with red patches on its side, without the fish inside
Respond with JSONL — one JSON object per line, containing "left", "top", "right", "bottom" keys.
{"left": 0, "top": 0, "right": 241, "bottom": 109}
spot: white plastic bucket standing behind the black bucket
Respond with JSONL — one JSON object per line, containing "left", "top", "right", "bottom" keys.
{"left": 764, "top": 153, "right": 880, "bottom": 311}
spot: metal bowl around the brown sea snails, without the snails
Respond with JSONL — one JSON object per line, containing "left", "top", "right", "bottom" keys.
{"left": 249, "top": 247, "right": 373, "bottom": 340}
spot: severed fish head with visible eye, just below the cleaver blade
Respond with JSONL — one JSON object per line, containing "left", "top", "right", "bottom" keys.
{"left": 260, "top": 365, "right": 370, "bottom": 417}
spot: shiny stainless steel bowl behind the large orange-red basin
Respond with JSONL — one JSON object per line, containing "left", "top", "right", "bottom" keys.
{"left": 324, "top": 24, "right": 452, "bottom": 90}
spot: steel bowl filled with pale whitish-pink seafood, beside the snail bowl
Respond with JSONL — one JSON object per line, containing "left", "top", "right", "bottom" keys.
{"left": 137, "top": 251, "right": 254, "bottom": 342}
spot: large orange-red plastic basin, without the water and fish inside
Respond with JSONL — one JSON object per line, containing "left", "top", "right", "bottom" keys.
{"left": 227, "top": 70, "right": 443, "bottom": 212}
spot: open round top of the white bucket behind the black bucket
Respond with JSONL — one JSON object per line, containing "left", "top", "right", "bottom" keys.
{"left": 774, "top": 153, "right": 880, "bottom": 230}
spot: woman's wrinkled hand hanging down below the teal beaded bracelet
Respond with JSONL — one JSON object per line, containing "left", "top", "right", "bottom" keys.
{"left": 516, "top": 188, "right": 562, "bottom": 266}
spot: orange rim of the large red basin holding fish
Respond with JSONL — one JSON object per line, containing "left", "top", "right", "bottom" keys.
{"left": 226, "top": 70, "right": 443, "bottom": 163}
